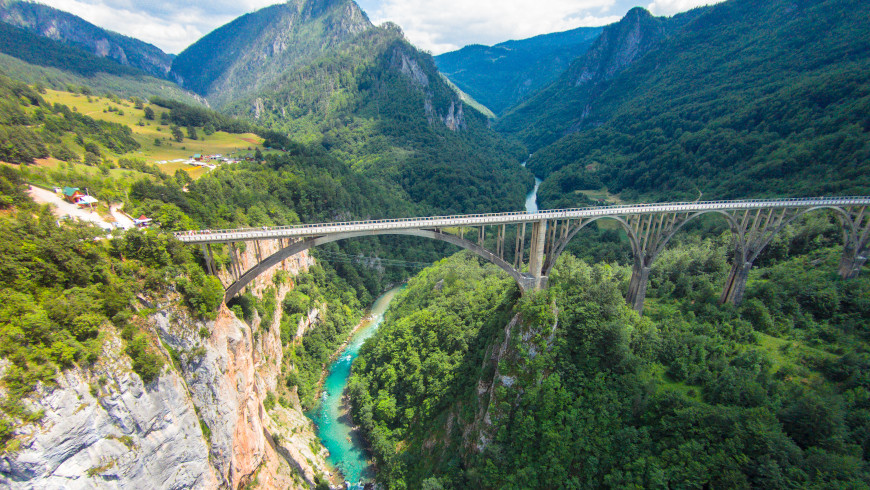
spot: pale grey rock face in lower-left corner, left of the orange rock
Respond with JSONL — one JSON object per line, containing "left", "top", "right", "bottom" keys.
{"left": 0, "top": 336, "right": 219, "bottom": 489}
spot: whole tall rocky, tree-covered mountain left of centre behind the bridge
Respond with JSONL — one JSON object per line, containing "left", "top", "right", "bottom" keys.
{"left": 173, "top": 0, "right": 532, "bottom": 213}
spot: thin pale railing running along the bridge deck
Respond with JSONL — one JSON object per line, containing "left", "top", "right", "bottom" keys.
{"left": 175, "top": 196, "right": 870, "bottom": 239}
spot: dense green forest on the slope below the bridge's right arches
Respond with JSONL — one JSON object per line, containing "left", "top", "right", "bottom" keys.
{"left": 350, "top": 216, "right": 870, "bottom": 488}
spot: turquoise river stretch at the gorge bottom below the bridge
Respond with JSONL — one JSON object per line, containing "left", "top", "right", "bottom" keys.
{"left": 308, "top": 287, "right": 401, "bottom": 488}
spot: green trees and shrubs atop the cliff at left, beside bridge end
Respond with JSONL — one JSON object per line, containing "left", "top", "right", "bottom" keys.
{"left": 0, "top": 190, "right": 223, "bottom": 451}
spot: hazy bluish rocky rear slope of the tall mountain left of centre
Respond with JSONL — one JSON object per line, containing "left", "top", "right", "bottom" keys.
{"left": 172, "top": 0, "right": 373, "bottom": 107}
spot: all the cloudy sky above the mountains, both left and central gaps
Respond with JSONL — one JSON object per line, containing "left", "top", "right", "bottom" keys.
{"left": 39, "top": 0, "right": 718, "bottom": 54}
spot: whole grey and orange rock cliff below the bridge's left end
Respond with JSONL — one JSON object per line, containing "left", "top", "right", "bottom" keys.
{"left": 0, "top": 249, "right": 330, "bottom": 489}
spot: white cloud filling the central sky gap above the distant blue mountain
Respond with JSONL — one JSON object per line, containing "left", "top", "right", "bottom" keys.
{"left": 369, "top": 0, "right": 621, "bottom": 54}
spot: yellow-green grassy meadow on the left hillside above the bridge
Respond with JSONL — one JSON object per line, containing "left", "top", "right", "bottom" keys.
{"left": 43, "top": 90, "right": 263, "bottom": 178}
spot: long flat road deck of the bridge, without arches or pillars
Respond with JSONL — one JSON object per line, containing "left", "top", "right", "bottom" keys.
{"left": 175, "top": 196, "right": 870, "bottom": 243}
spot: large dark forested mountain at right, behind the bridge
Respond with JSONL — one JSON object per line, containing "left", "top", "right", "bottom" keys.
{"left": 497, "top": 0, "right": 870, "bottom": 207}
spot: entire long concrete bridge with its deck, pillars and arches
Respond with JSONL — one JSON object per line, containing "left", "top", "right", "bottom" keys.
{"left": 175, "top": 196, "right": 870, "bottom": 312}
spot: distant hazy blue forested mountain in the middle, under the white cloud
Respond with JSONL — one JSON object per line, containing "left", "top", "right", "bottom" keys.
{"left": 435, "top": 27, "right": 602, "bottom": 114}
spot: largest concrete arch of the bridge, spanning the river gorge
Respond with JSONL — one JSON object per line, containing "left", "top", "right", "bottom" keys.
{"left": 224, "top": 229, "right": 535, "bottom": 301}
